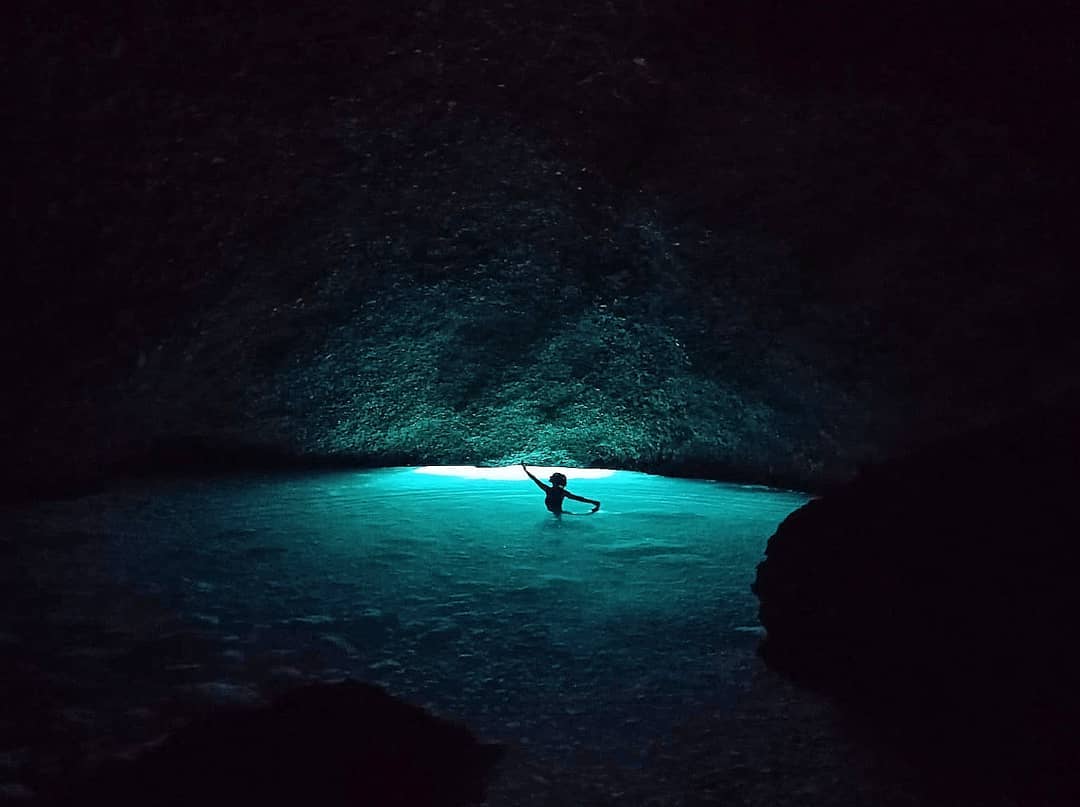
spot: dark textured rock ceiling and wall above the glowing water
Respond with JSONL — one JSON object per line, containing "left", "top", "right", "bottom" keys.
{"left": 3, "top": 0, "right": 1080, "bottom": 499}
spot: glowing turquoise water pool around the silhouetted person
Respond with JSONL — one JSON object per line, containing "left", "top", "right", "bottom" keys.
{"left": 0, "top": 469, "right": 806, "bottom": 773}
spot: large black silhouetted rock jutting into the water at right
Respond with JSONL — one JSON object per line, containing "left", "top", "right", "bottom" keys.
{"left": 754, "top": 408, "right": 1080, "bottom": 803}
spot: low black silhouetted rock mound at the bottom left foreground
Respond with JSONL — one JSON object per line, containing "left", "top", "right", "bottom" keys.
{"left": 48, "top": 682, "right": 502, "bottom": 807}
